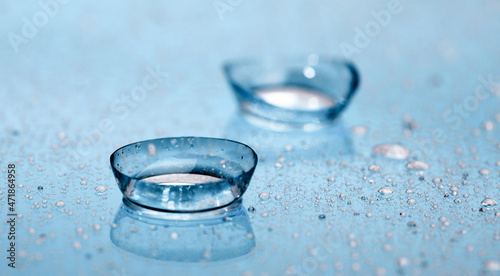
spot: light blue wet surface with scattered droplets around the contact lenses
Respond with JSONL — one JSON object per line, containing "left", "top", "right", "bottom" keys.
{"left": 0, "top": 0, "right": 500, "bottom": 275}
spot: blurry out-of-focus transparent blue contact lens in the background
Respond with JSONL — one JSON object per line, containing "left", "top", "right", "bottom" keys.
{"left": 224, "top": 54, "right": 359, "bottom": 131}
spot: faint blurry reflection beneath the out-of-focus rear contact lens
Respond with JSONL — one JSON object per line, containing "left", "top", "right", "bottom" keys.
{"left": 226, "top": 113, "right": 353, "bottom": 159}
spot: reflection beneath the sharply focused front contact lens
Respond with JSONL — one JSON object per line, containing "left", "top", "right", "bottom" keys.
{"left": 110, "top": 201, "right": 255, "bottom": 262}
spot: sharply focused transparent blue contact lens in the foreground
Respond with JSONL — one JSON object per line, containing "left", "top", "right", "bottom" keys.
{"left": 110, "top": 137, "right": 257, "bottom": 212}
